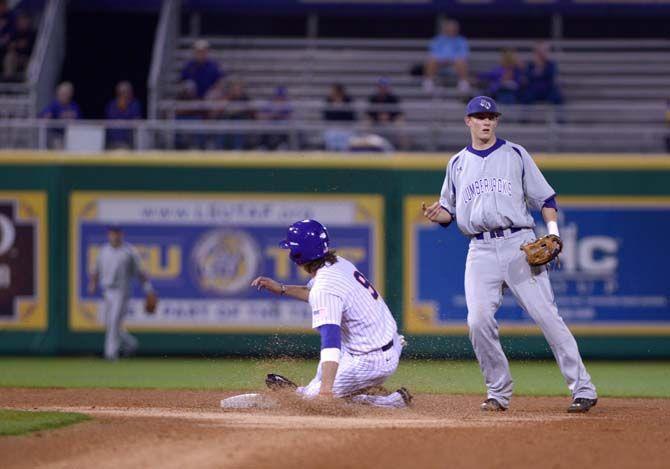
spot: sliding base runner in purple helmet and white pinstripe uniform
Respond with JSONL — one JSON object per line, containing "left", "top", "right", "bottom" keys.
{"left": 251, "top": 220, "right": 412, "bottom": 407}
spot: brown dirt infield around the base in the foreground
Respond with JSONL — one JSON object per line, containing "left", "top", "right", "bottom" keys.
{"left": 0, "top": 389, "right": 670, "bottom": 469}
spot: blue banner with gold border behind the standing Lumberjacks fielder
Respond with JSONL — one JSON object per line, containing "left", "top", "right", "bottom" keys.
{"left": 404, "top": 196, "right": 670, "bottom": 335}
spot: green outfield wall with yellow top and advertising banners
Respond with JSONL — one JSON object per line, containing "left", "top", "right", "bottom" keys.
{"left": 0, "top": 152, "right": 670, "bottom": 359}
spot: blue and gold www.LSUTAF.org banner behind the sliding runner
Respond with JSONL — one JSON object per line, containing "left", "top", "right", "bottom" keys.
{"left": 69, "top": 192, "right": 384, "bottom": 333}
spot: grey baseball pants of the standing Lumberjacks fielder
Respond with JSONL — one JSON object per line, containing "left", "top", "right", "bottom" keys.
{"left": 465, "top": 229, "right": 597, "bottom": 407}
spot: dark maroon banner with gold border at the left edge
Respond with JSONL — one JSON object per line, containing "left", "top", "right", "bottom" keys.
{"left": 0, "top": 191, "right": 48, "bottom": 331}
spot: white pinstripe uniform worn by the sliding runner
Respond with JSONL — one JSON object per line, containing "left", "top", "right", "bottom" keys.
{"left": 298, "top": 257, "right": 405, "bottom": 407}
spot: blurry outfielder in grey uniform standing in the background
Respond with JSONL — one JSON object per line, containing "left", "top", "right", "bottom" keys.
{"left": 88, "top": 226, "right": 153, "bottom": 361}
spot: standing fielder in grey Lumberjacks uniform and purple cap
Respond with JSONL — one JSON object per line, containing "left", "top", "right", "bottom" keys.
{"left": 422, "top": 96, "right": 597, "bottom": 412}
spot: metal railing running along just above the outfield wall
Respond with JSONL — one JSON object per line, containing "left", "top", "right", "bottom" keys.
{"left": 0, "top": 119, "right": 670, "bottom": 153}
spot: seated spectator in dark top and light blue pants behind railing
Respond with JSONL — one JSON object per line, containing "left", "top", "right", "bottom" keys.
{"left": 323, "top": 83, "right": 357, "bottom": 151}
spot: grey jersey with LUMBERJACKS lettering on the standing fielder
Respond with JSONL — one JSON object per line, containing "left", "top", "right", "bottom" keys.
{"left": 440, "top": 138, "right": 555, "bottom": 236}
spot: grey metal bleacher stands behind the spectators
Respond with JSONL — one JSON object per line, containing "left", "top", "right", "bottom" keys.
{"left": 0, "top": 0, "right": 670, "bottom": 153}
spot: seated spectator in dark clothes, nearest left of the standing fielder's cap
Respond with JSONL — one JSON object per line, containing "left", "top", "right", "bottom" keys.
{"left": 367, "top": 77, "right": 408, "bottom": 149}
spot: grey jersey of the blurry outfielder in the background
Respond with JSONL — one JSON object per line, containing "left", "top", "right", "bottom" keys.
{"left": 95, "top": 243, "right": 142, "bottom": 291}
